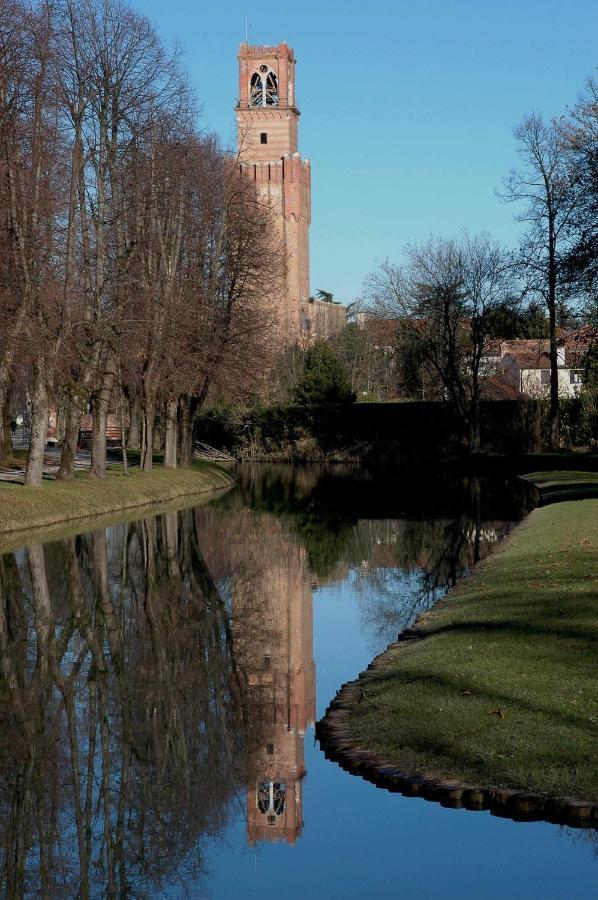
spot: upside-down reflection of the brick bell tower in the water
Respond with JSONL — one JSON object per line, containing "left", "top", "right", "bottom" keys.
{"left": 206, "top": 511, "right": 316, "bottom": 844}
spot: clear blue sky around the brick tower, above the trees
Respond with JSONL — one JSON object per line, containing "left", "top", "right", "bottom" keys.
{"left": 133, "top": 0, "right": 598, "bottom": 302}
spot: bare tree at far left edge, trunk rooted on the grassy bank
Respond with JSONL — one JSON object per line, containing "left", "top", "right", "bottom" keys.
{"left": 0, "top": 4, "right": 67, "bottom": 486}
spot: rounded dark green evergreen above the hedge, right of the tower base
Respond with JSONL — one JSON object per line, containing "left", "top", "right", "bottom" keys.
{"left": 293, "top": 341, "right": 355, "bottom": 406}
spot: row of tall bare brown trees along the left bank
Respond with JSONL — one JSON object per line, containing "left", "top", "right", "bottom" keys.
{"left": 0, "top": 0, "right": 284, "bottom": 484}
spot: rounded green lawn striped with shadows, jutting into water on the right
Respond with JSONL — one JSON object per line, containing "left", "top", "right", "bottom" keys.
{"left": 349, "top": 496, "right": 598, "bottom": 800}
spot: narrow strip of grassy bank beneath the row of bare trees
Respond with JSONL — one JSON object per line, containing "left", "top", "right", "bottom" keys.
{"left": 0, "top": 462, "right": 234, "bottom": 547}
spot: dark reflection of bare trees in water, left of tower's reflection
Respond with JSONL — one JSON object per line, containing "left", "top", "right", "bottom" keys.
{"left": 0, "top": 513, "right": 245, "bottom": 897}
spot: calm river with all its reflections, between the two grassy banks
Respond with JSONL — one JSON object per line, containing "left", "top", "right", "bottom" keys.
{"left": 0, "top": 466, "right": 598, "bottom": 900}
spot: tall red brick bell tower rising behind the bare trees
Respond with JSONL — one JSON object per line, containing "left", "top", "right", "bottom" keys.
{"left": 235, "top": 43, "right": 311, "bottom": 343}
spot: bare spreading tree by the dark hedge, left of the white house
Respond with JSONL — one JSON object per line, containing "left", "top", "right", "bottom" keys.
{"left": 366, "top": 232, "right": 511, "bottom": 452}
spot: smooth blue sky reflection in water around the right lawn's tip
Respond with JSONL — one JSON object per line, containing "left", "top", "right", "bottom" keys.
{"left": 200, "top": 572, "right": 598, "bottom": 900}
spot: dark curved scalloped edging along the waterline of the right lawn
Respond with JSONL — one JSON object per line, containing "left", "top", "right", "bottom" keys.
{"left": 316, "top": 624, "right": 598, "bottom": 828}
